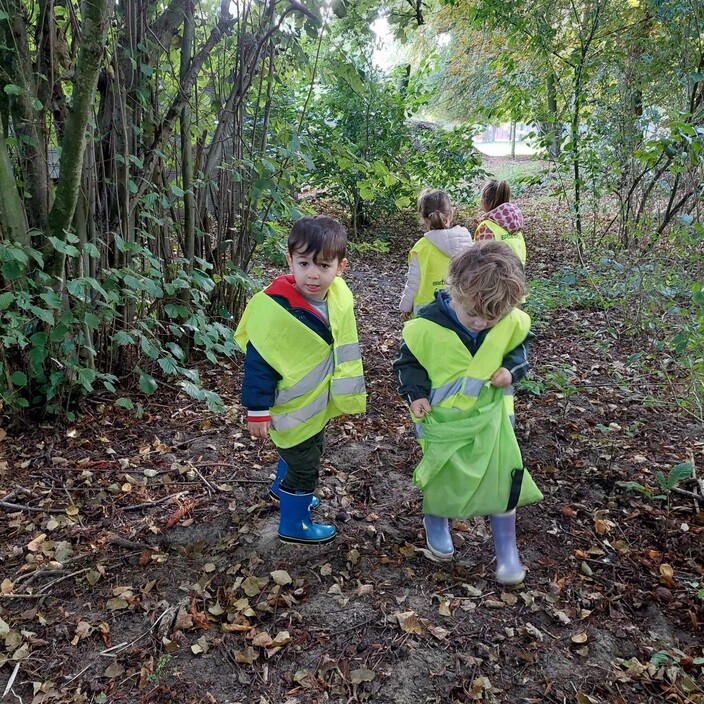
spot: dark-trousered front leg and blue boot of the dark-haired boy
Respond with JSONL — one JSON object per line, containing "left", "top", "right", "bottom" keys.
{"left": 279, "top": 430, "right": 336, "bottom": 543}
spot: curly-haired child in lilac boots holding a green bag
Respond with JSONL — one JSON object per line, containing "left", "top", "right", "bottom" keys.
{"left": 394, "top": 241, "right": 542, "bottom": 584}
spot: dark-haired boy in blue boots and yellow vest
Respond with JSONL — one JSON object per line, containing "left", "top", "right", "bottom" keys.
{"left": 235, "top": 215, "right": 366, "bottom": 543}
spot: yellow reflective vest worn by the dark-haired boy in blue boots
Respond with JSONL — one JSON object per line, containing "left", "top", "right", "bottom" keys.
{"left": 235, "top": 276, "right": 367, "bottom": 447}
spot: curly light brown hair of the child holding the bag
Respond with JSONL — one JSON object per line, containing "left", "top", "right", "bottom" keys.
{"left": 447, "top": 240, "right": 526, "bottom": 320}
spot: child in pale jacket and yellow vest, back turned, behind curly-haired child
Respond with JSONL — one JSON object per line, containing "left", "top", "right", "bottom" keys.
{"left": 399, "top": 188, "right": 472, "bottom": 314}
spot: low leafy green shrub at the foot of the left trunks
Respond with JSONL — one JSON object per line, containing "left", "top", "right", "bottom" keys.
{"left": 0, "top": 235, "right": 235, "bottom": 417}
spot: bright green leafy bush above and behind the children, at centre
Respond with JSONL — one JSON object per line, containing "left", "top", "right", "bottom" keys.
{"left": 304, "top": 32, "right": 484, "bottom": 231}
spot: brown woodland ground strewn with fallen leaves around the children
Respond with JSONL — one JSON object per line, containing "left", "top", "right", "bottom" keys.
{"left": 0, "top": 161, "right": 704, "bottom": 704}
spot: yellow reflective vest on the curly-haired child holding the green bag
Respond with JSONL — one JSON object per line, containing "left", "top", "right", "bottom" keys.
{"left": 403, "top": 308, "right": 530, "bottom": 438}
